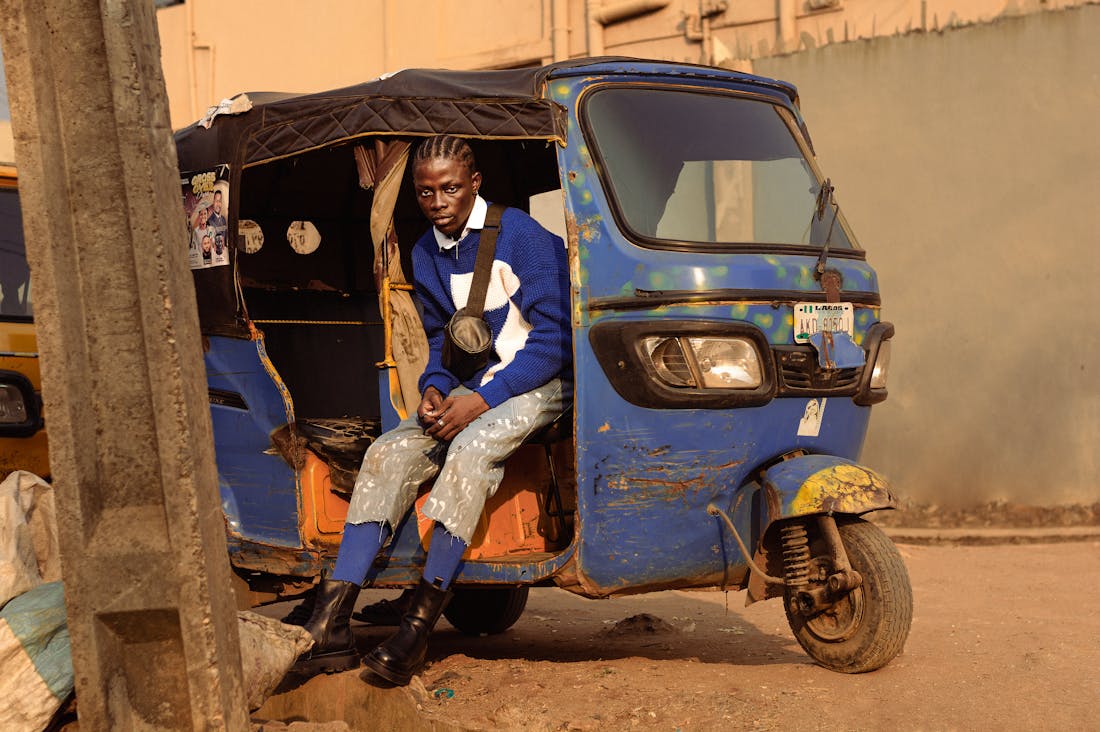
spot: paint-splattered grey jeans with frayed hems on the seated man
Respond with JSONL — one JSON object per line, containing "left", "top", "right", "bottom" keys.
{"left": 348, "top": 379, "right": 573, "bottom": 544}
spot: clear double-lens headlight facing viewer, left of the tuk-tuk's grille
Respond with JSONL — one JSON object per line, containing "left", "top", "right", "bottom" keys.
{"left": 642, "top": 336, "right": 763, "bottom": 389}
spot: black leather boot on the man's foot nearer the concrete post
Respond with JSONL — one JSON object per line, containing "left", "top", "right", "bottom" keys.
{"left": 293, "top": 579, "right": 360, "bottom": 676}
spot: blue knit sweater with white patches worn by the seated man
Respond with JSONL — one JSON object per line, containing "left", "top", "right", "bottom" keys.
{"left": 413, "top": 208, "right": 573, "bottom": 407}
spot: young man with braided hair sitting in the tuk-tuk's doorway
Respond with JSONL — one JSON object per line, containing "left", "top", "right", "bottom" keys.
{"left": 298, "top": 135, "right": 572, "bottom": 685}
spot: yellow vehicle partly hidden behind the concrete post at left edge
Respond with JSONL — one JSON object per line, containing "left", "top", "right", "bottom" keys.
{"left": 0, "top": 165, "right": 50, "bottom": 479}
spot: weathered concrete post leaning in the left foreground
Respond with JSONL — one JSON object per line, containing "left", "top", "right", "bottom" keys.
{"left": 0, "top": 0, "right": 249, "bottom": 730}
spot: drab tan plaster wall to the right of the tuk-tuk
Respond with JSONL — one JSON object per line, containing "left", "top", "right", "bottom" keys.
{"left": 756, "top": 6, "right": 1100, "bottom": 504}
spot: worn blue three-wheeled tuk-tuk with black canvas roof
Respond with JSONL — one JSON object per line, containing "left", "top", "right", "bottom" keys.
{"left": 176, "top": 58, "right": 912, "bottom": 673}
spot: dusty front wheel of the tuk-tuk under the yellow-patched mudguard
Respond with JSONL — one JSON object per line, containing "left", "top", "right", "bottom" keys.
{"left": 784, "top": 517, "right": 913, "bottom": 674}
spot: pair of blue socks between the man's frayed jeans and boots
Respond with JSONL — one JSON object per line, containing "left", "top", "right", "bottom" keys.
{"left": 331, "top": 521, "right": 466, "bottom": 590}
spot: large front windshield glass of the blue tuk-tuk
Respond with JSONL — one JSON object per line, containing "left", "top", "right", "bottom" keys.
{"left": 585, "top": 87, "right": 853, "bottom": 250}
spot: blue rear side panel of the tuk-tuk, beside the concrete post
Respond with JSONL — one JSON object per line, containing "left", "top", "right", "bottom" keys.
{"left": 206, "top": 337, "right": 301, "bottom": 547}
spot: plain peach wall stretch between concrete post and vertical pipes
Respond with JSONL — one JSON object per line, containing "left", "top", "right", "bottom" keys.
{"left": 157, "top": 0, "right": 552, "bottom": 128}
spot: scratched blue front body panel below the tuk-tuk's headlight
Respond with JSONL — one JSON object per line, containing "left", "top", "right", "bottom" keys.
{"left": 576, "top": 338, "right": 870, "bottom": 590}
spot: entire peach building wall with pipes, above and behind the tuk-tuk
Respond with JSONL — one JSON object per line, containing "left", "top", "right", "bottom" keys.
{"left": 157, "top": 0, "right": 1088, "bottom": 128}
